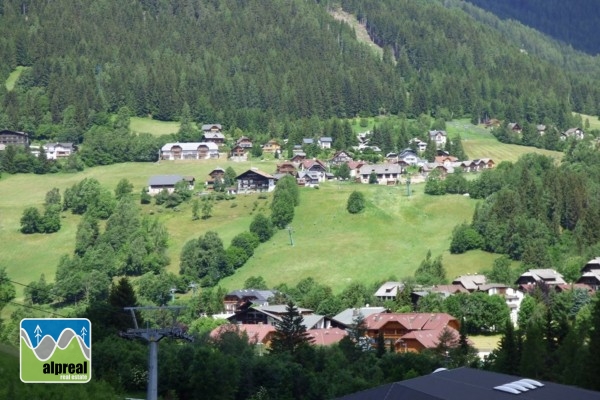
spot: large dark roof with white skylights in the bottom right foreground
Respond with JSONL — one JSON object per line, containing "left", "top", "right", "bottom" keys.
{"left": 338, "top": 368, "right": 600, "bottom": 400}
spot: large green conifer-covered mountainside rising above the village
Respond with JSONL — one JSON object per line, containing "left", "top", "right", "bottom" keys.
{"left": 0, "top": 0, "right": 600, "bottom": 141}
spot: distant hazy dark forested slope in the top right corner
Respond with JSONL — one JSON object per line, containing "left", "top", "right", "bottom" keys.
{"left": 469, "top": 0, "right": 600, "bottom": 55}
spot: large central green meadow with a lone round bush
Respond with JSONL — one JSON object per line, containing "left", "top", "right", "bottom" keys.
{"left": 221, "top": 183, "right": 497, "bottom": 292}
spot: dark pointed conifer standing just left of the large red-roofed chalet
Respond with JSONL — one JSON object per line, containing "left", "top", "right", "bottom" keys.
{"left": 271, "top": 302, "right": 311, "bottom": 354}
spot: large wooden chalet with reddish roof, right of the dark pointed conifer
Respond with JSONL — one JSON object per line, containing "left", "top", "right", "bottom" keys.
{"left": 364, "top": 313, "right": 460, "bottom": 353}
